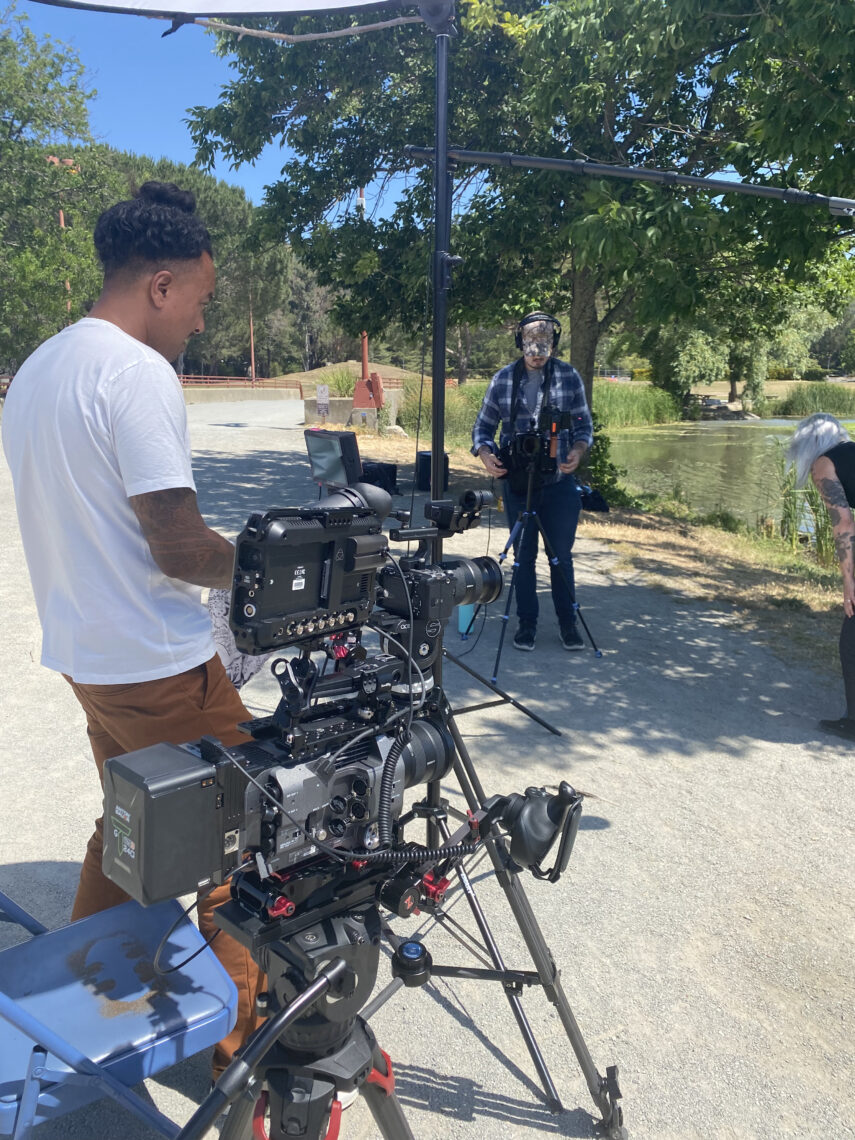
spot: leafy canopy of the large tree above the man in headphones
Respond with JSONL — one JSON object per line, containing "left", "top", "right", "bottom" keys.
{"left": 193, "top": 0, "right": 850, "bottom": 410}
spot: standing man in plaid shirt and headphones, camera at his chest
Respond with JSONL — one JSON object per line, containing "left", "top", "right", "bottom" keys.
{"left": 472, "top": 311, "right": 594, "bottom": 652}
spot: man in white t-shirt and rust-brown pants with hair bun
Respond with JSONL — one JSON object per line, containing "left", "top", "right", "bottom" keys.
{"left": 2, "top": 182, "right": 259, "bottom": 1072}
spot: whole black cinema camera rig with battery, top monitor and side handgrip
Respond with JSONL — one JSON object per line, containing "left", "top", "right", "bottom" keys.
{"left": 104, "top": 432, "right": 580, "bottom": 926}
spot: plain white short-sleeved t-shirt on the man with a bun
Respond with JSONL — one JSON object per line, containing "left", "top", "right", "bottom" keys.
{"left": 2, "top": 317, "right": 215, "bottom": 685}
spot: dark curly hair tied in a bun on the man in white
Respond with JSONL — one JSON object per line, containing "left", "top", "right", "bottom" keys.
{"left": 95, "top": 182, "right": 212, "bottom": 277}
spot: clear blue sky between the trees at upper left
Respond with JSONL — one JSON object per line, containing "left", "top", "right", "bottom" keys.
{"left": 18, "top": 0, "right": 285, "bottom": 204}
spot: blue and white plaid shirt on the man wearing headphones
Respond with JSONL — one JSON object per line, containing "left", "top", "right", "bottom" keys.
{"left": 472, "top": 359, "right": 594, "bottom": 463}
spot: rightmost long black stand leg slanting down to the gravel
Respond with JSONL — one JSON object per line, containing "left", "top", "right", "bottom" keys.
{"left": 448, "top": 716, "right": 627, "bottom": 1140}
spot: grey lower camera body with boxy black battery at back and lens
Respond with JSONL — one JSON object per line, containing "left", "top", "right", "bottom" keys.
{"left": 104, "top": 713, "right": 453, "bottom": 913}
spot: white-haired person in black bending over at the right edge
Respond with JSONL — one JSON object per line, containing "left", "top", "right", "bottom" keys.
{"left": 787, "top": 412, "right": 855, "bottom": 741}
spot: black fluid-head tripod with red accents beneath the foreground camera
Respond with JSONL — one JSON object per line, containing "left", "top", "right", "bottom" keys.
{"left": 179, "top": 903, "right": 414, "bottom": 1140}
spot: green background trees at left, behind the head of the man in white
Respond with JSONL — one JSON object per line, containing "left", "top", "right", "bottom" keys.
{"left": 0, "top": 8, "right": 334, "bottom": 375}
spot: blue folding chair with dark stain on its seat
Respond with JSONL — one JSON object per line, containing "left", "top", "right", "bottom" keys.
{"left": 0, "top": 891, "right": 237, "bottom": 1140}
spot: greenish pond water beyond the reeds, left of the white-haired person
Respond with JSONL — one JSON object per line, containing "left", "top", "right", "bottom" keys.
{"left": 609, "top": 420, "right": 798, "bottom": 523}
